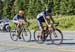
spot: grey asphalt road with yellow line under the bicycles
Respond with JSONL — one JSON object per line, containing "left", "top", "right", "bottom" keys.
{"left": 0, "top": 31, "right": 75, "bottom": 52}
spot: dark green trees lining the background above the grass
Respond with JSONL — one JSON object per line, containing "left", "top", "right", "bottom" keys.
{"left": 0, "top": 0, "right": 75, "bottom": 19}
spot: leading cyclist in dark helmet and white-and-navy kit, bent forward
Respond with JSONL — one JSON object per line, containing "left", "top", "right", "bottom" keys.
{"left": 37, "top": 7, "right": 54, "bottom": 39}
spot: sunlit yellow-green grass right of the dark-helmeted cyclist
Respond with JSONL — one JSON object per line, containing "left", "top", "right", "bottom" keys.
{"left": 55, "top": 16, "right": 75, "bottom": 30}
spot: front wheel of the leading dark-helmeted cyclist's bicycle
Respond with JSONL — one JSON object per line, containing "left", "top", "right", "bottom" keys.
{"left": 50, "top": 29, "right": 63, "bottom": 45}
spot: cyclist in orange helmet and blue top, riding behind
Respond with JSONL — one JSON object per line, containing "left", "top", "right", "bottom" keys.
{"left": 13, "top": 9, "right": 29, "bottom": 39}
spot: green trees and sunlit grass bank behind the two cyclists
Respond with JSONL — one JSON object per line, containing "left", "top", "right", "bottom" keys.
{"left": 0, "top": 0, "right": 75, "bottom": 30}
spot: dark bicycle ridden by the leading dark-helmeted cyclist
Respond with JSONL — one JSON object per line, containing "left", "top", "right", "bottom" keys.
{"left": 34, "top": 23, "right": 63, "bottom": 44}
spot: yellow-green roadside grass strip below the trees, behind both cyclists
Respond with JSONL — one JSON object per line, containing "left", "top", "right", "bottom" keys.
{"left": 10, "top": 16, "right": 75, "bottom": 31}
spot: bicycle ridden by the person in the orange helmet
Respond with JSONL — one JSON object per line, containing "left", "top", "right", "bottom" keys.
{"left": 10, "top": 23, "right": 31, "bottom": 42}
